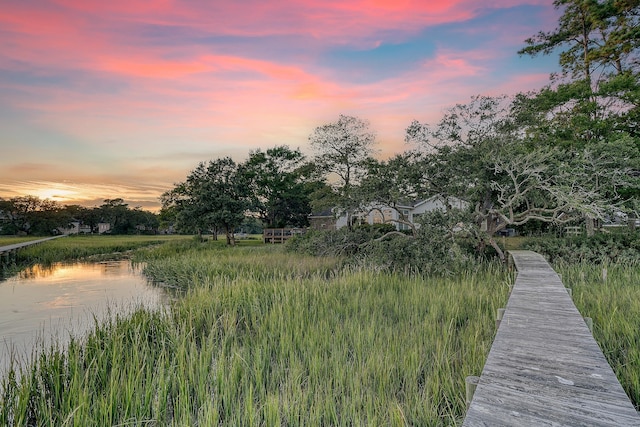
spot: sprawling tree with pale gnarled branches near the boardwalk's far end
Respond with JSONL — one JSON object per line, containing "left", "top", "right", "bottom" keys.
{"left": 407, "top": 98, "right": 635, "bottom": 258}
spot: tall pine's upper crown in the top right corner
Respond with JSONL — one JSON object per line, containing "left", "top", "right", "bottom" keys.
{"left": 519, "top": 0, "right": 640, "bottom": 147}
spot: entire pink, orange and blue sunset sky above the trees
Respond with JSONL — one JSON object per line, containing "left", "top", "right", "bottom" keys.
{"left": 0, "top": 0, "right": 560, "bottom": 210}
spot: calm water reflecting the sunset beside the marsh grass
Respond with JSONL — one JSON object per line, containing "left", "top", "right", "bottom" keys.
{"left": 0, "top": 261, "right": 166, "bottom": 374}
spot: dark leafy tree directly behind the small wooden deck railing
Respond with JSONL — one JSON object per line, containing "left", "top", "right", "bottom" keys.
{"left": 243, "top": 145, "right": 311, "bottom": 228}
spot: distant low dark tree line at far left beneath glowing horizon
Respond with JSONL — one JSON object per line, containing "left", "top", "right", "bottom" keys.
{"left": 0, "top": 196, "right": 160, "bottom": 235}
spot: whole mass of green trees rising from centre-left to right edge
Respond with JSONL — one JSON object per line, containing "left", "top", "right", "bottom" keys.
{"left": 162, "top": 0, "right": 640, "bottom": 256}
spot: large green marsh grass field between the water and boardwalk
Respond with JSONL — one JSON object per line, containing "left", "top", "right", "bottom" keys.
{"left": 0, "top": 242, "right": 508, "bottom": 426}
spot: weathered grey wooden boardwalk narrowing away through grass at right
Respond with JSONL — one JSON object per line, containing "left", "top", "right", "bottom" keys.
{"left": 463, "top": 251, "right": 640, "bottom": 427}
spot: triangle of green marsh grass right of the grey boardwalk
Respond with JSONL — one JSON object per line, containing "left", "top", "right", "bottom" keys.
{"left": 556, "top": 263, "right": 640, "bottom": 409}
